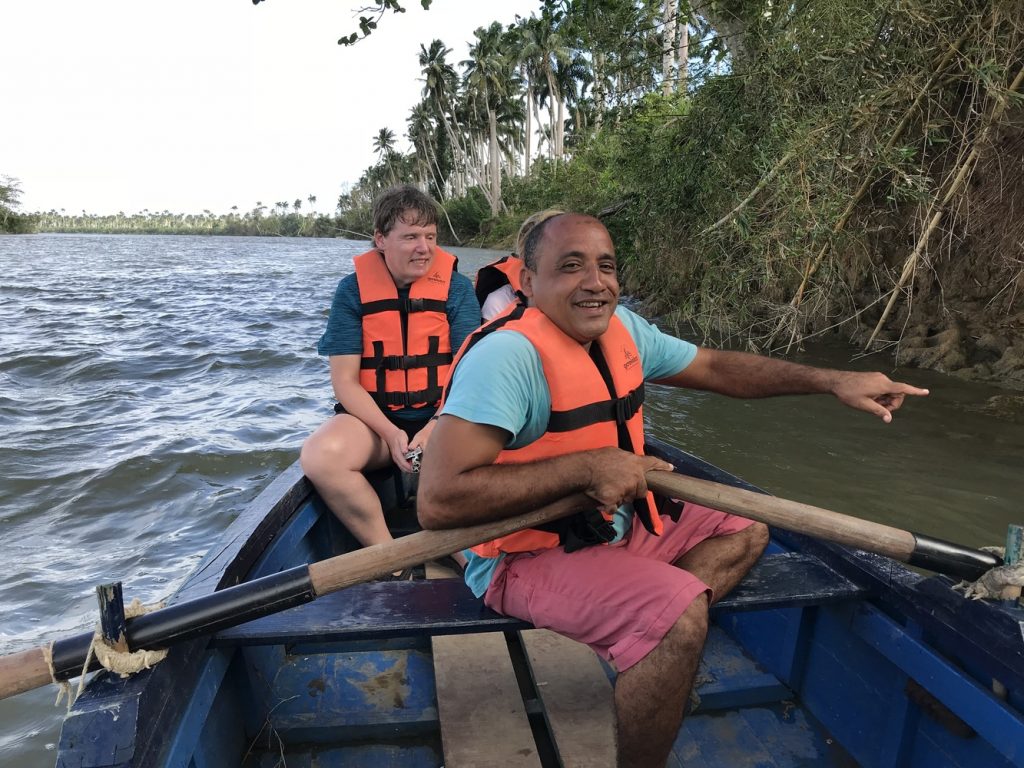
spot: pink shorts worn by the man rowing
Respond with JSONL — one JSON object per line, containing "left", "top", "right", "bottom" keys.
{"left": 483, "top": 503, "right": 752, "bottom": 672}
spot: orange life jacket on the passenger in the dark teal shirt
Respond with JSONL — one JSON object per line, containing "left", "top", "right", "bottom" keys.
{"left": 355, "top": 248, "right": 456, "bottom": 411}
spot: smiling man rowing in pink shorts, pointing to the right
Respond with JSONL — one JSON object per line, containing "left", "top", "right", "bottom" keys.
{"left": 418, "top": 214, "right": 927, "bottom": 768}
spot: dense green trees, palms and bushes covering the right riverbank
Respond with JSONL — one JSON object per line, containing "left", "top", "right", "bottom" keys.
{"left": 340, "top": 0, "right": 1024, "bottom": 382}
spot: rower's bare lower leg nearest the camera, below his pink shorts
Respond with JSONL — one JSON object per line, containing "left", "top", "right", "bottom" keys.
{"left": 615, "top": 593, "right": 708, "bottom": 768}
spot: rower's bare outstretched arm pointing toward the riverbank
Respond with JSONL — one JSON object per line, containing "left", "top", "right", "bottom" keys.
{"left": 657, "top": 347, "right": 928, "bottom": 424}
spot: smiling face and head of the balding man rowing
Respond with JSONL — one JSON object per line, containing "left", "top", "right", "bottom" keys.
{"left": 522, "top": 214, "right": 618, "bottom": 344}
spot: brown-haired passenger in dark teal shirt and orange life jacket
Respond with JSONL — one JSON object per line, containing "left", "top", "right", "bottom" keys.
{"left": 301, "top": 186, "right": 480, "bottom": 561}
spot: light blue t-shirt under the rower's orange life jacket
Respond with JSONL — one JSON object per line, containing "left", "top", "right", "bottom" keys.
{"left": 441, "top": 306, "right": 697, "bottom": 597}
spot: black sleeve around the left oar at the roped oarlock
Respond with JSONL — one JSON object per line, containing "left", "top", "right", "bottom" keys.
{"left": 52, "top": 565, "right": 316, "bottom": 681}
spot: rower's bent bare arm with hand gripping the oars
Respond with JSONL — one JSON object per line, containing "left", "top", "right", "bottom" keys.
{"left": 417, "top": 415, "right": 672, "bottom": 528}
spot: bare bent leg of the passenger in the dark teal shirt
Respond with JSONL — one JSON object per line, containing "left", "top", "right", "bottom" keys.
{"left": 299, "top": 414, "right": 391, "bottom": 546}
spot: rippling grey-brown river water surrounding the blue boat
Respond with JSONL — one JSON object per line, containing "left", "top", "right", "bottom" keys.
{"left": 0, "top": 234, "right": 1024, "bottom": 768}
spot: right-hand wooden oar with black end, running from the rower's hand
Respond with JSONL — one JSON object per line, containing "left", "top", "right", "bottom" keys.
{"left": 647, "top": 470, "right": 1002, "bottom": 581}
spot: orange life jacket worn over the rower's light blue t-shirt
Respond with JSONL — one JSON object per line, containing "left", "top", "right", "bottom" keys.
{"left": 454, "top": 305, "right": 662, "bottom": 557}
